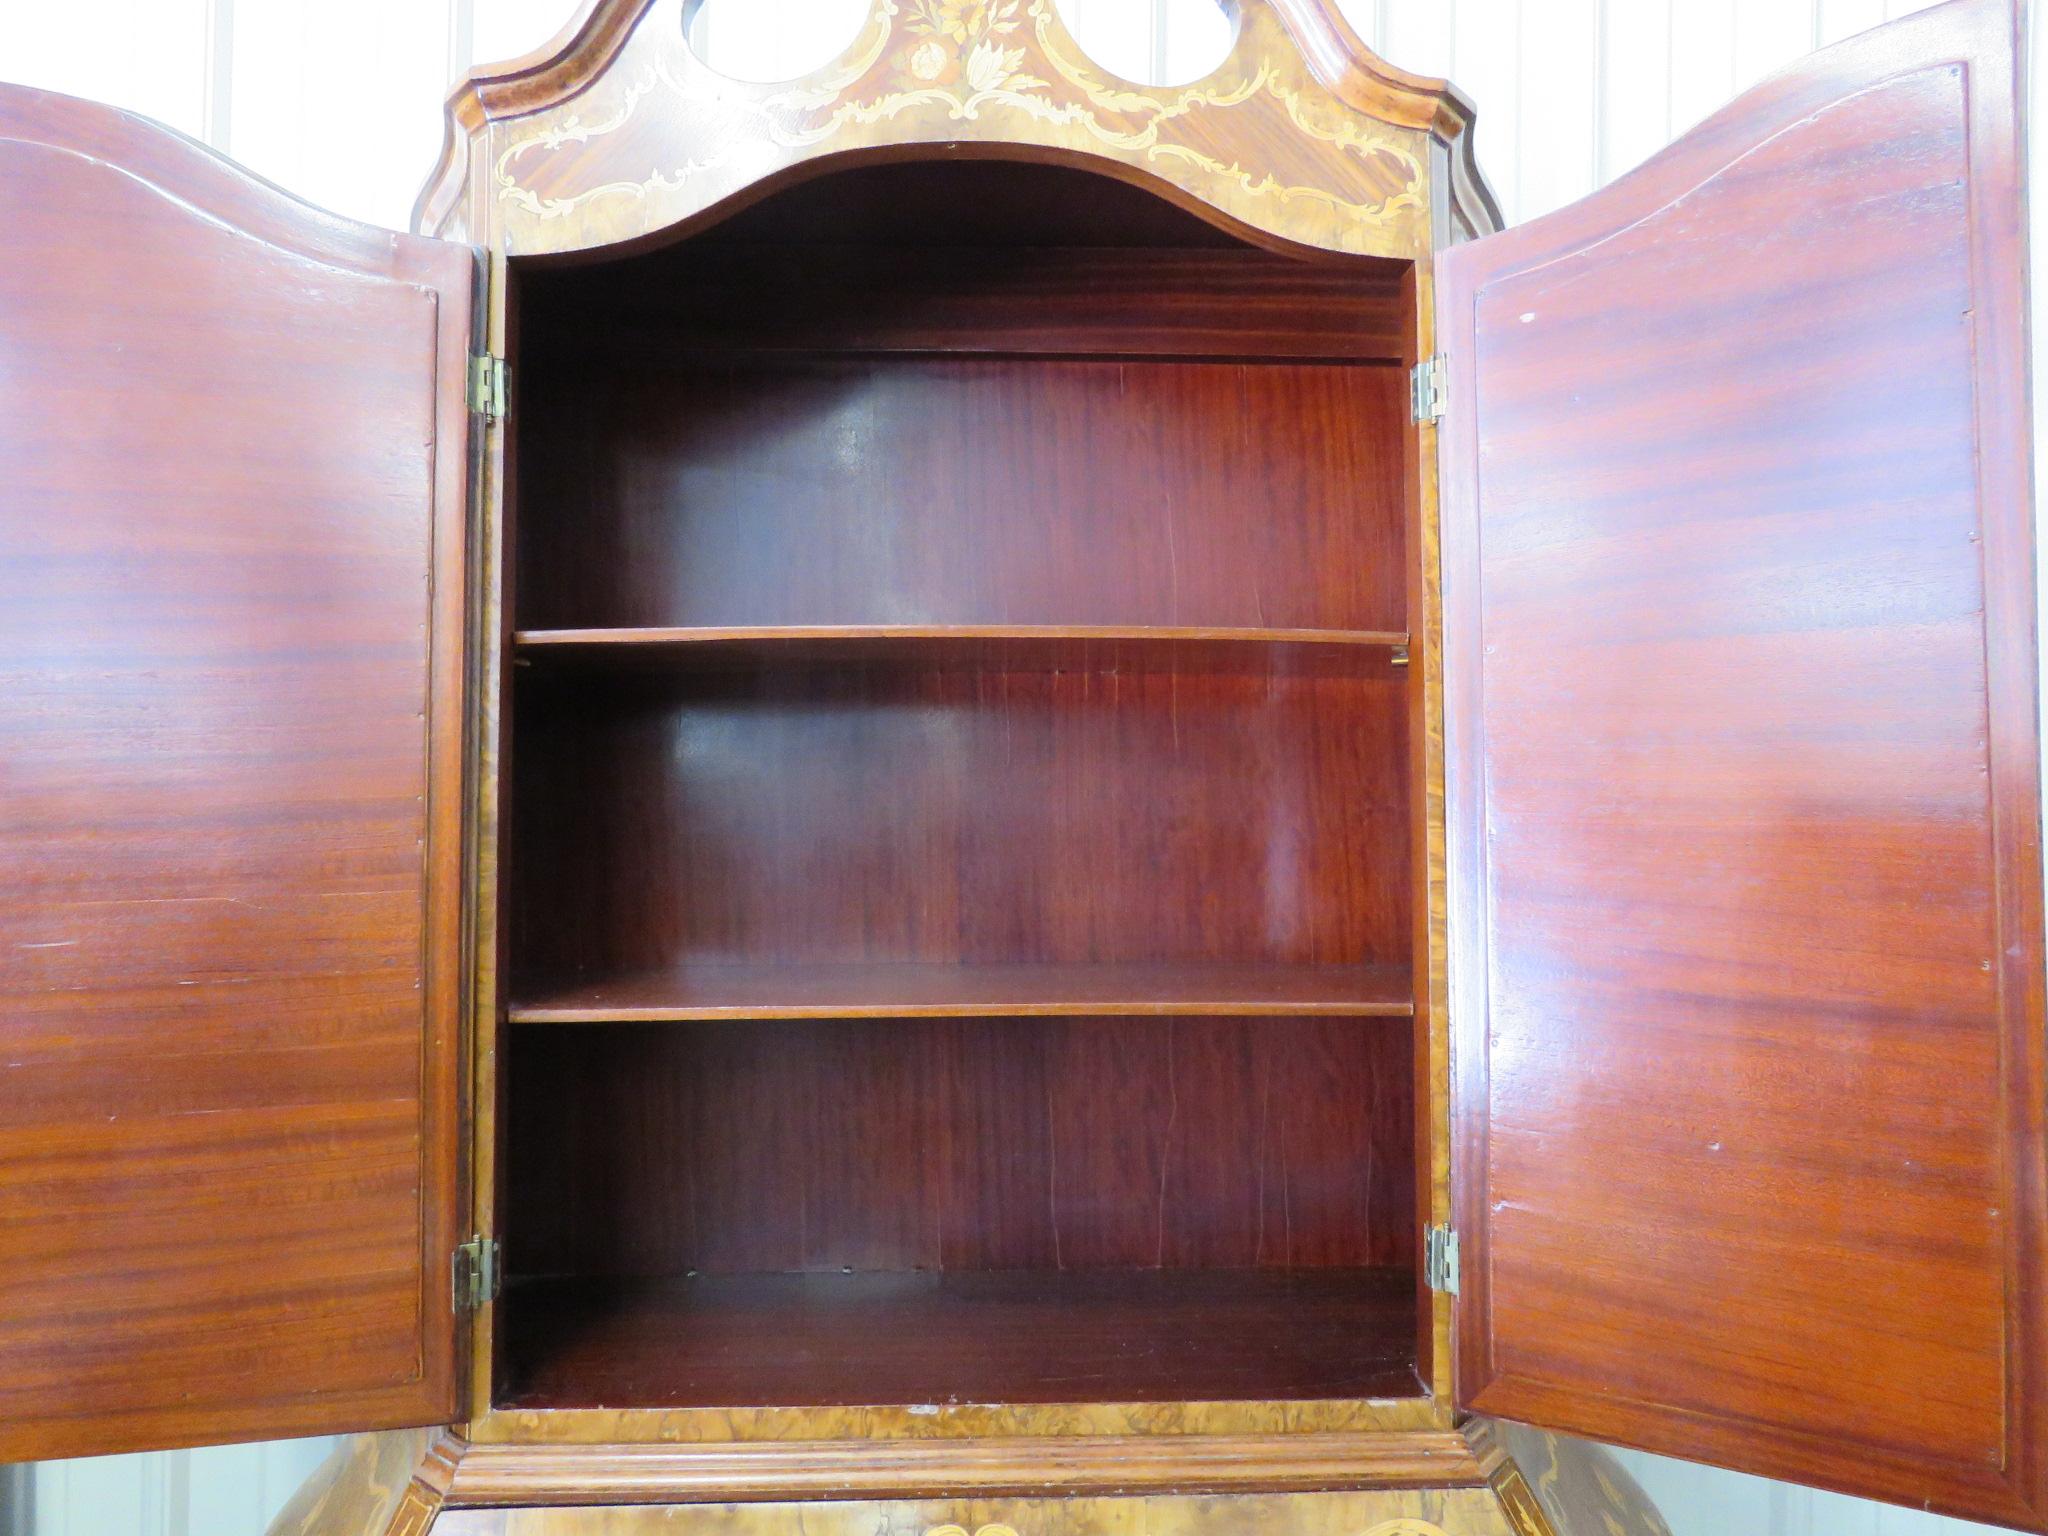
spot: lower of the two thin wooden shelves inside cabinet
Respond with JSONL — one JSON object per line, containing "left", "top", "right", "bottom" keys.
{"left": 510, "top": 965, "right": 1415, "bottom": 1024}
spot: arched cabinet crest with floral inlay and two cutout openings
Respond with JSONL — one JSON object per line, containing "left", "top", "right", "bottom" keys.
{"left": 414, "top": 0, "right": 1499, "bottom": 258}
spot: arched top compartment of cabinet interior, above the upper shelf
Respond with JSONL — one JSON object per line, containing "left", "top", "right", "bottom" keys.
{"left": 514, "top": 183, "right": 1409, "bottom": 633}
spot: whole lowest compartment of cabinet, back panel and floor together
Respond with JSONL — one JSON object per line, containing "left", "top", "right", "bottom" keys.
{"left": 500, "top": 1018, "right": 1415, "bottom": 1405}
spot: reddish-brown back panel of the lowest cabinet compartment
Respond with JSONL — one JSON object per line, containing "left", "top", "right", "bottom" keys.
{"left": 504, "top": 1018, "right": 1415, "bottom": 1277}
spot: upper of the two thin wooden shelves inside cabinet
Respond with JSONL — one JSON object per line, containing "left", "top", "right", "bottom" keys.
{"left": 514, "top": 625, "right": 1409, "bottom": 676}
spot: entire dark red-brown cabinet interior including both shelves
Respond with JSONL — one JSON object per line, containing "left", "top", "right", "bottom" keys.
{"left": 496, "top": 164, "right": 1417, "bottom": 1407}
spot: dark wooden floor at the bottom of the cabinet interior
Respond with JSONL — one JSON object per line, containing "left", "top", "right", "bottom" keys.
{"left": 500, "top": 1270, "right": 1421, "bottom": 1409}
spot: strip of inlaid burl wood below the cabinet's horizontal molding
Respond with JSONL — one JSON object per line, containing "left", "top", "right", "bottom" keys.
{"left": 434, "top": 1489, "right": 1523, "bottom": 1536}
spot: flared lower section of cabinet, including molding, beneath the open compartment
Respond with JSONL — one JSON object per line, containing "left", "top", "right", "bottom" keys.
{"left": 270, "top": 1421, "right": 1669, "bottom": 1536}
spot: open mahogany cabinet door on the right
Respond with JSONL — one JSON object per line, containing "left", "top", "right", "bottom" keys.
{"left": 1438, "top": 0, "right": 2048, "bottom": 1528}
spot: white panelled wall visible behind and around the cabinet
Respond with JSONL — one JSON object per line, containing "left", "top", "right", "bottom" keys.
{"left": 0, "top": 0, "right": 2023, "bottom": 1536}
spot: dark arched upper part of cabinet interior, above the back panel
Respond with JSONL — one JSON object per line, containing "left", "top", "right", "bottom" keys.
{"left": 512, "top": 152, "right": 1411, "bottom": 362}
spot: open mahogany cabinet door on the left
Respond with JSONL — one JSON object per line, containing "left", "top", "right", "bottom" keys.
{"left": 0, "top": 88, "right": 475, "bottom": 1460}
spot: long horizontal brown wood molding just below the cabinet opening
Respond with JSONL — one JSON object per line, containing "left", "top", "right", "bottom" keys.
{"left": 436, "top": 1432, "right": 1487, "bottom": 1507}
